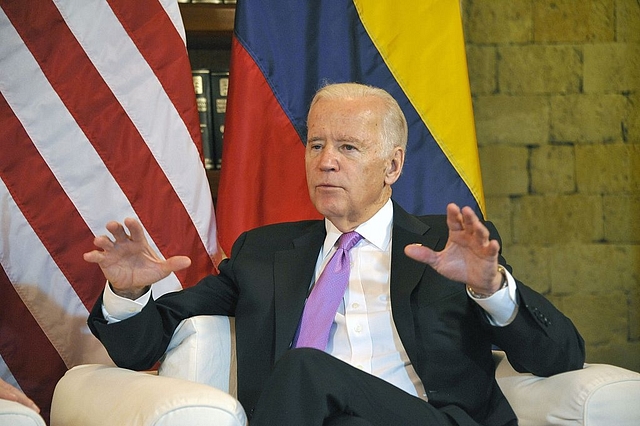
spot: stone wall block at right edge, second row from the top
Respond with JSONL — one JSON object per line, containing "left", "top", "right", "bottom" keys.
{"left": 583, "top": 42, "right": 640, "bottom": 93}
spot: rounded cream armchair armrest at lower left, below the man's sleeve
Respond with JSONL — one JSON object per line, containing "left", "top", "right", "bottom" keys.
{"left": 51, "top": 364, "right": 247, "bottom": 426}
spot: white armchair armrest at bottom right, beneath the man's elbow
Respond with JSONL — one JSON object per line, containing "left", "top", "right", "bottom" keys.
{"left": 494, "top": 351, "right": 640, "bottom": 426}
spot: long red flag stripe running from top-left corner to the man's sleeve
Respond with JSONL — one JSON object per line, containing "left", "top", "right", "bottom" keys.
{"left": 5, "top": 0, "right": 213, "bottom": 285}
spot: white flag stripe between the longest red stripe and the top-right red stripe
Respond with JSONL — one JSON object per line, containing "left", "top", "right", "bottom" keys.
{"left": 56, "top": 0, "right": 217, "bottom": 253}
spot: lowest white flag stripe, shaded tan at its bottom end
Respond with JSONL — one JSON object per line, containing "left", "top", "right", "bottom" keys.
{"left": 0, "top": 180, "right": 111, "bottom": 367}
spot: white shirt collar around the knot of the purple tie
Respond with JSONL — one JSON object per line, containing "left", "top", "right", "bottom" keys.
{"left": 322, "top": 199, "right": 393, "bottom": 257}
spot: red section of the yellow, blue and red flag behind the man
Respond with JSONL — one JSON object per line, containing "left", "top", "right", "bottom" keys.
{"left": 216, "top": 38, "right": 321, "bottom": 253}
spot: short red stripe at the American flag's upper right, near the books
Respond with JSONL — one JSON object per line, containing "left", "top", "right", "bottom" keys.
{"left": 108, "top": 0, "right": 202, "bottom": 152}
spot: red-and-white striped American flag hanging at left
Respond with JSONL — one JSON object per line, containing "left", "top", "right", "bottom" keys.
{"left": 0, "top": 0, "right": 221, "bottom": 417}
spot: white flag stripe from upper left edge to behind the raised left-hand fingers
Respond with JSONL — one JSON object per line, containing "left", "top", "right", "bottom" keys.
{"left": 0, "top": 9, "right": 181, "bottom": 297}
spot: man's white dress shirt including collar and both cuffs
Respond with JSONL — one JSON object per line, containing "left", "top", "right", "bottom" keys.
{"left": 102, "top": 200, "right": 518, "bottom": 399}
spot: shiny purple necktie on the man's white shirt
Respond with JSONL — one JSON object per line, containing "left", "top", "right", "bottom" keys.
{"left": 295, "top": 231, "right": 362, "bottom": 351}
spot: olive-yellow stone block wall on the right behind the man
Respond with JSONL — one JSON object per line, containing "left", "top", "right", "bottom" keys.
{"left": 461, "top": 0, "right": 640, "bottom": 371}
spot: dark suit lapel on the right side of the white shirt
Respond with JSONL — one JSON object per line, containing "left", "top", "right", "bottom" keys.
{"left": 391, "top": 203, "right": 439, "bottom": 362}
